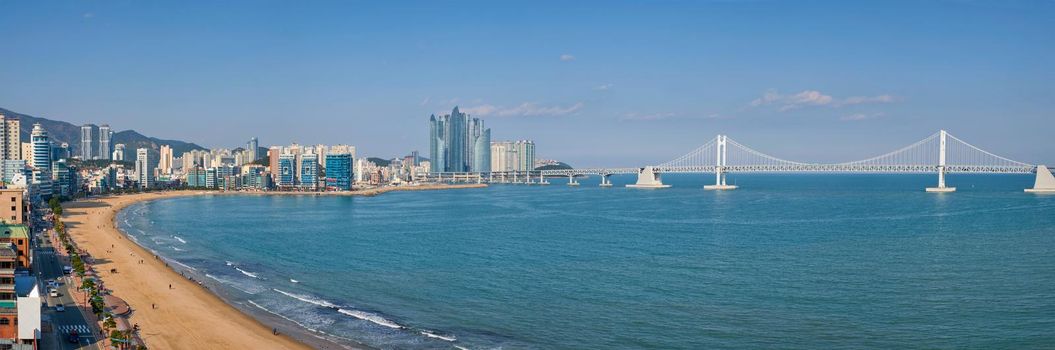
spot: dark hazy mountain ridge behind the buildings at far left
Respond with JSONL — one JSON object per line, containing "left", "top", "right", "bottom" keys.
{"left": 0, "top": 105, "right": 207, "bottom": 159}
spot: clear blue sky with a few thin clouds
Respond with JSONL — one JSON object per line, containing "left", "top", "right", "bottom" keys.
{"left": 0, "top": 0, "right": 1055, "bottom": 167}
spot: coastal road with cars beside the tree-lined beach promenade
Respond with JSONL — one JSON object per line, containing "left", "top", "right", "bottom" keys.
{"left": 33, "top": 226, "right": 103, "bottom": 350}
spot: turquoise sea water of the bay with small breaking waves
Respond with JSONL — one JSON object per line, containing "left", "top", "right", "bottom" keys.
{"left": 118, "top": 175, "right": 1055, "bottom": 349}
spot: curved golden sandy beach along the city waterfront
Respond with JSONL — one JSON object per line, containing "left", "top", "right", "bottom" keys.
{"left": 62, "top": 184, "right": 485, "bottom": 349}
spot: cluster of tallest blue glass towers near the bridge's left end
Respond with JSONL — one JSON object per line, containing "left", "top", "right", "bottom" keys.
{"left": 428, "top": 106, "right": 491, "bottom": 173}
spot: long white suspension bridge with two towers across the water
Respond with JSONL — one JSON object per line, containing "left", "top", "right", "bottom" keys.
{"left": 539, "top": 130, "right": 1055, "bottom": 192}
